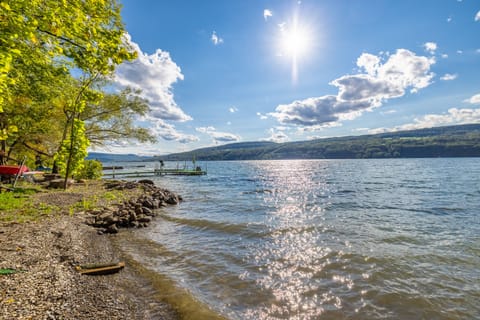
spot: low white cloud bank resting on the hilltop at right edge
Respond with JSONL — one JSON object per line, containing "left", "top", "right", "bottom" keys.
{"left": 369, "top": 108, "right": 480, "bottom": 134}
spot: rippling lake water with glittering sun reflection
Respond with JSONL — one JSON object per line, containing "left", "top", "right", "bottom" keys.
{"left": 113, "top": 158, "right": 480, "bottom": 319}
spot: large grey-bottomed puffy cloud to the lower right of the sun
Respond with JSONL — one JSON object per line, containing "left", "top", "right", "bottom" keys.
{"left": 269, "top": 49, "right": 435, "bottom": 129}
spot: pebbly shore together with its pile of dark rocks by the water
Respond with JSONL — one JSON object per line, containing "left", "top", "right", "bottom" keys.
{"left": 0, "top": 181, "right": 181, "bottom": 320}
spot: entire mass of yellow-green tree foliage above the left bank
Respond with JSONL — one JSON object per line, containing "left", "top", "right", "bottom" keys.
{"left": 0, "top": 0, "right": 153, "bottom": 180}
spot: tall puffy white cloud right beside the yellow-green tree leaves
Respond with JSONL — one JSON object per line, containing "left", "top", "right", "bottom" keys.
{"left": 115, "top": 34, "right": 192, "bottom": 121}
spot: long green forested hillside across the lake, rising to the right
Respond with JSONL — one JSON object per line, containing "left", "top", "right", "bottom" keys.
{"left": 157, "top": 124, "right": 480, "bottom": 161}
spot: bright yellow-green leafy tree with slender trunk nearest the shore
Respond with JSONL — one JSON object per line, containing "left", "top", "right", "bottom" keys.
{"left": 0, "top": 0, "right": 135, "bottom": 184}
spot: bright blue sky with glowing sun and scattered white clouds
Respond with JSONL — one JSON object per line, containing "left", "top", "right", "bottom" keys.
{"left": 93, "top": 0, "right": 480, "bottom": 155}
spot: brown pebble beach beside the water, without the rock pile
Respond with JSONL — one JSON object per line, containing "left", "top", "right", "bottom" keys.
{"left": 0, "top": 181, "right": 179, "bottom": 320}
